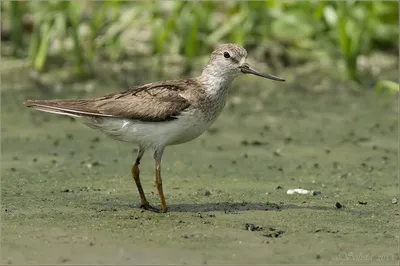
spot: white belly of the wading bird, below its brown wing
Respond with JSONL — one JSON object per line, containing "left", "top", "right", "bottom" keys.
{"left": 85, "top": 109, "right": 214, "bottom": 148}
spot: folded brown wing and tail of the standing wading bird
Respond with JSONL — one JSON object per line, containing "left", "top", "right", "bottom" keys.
{"left": 24, "top": 80, "right": 193, "bottom": 122}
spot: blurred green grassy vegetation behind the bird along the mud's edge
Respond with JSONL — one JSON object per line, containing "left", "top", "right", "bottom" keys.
{"left": 1, "top": 0, "right": 399, "bottom": 82}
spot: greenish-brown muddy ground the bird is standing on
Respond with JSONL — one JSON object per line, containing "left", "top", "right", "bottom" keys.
{"left": 1, "top": 59, "right": 399, "bottom": 264}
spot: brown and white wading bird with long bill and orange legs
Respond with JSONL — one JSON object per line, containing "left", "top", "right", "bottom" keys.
{"left": 24, "top": 43, "right": 285, "bottom": 213}
